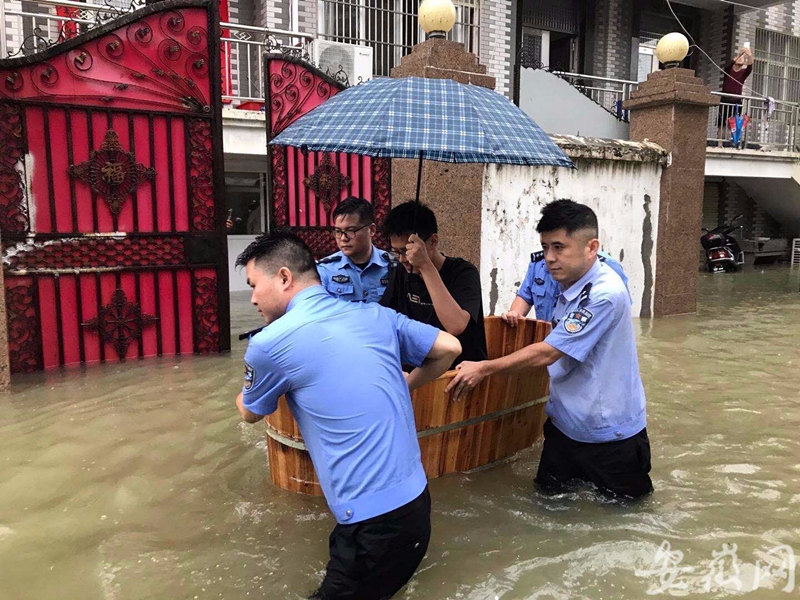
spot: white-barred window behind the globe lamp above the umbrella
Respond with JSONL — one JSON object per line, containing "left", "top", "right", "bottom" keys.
{"left": 319, "top": 0, "right": 480, "bottom": 76}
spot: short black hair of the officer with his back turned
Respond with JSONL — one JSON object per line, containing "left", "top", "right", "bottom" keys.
{"left": 236, "top": 229, "right": 319, "bottom": 279}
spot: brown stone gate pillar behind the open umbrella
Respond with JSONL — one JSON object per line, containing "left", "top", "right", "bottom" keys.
{"left": 391, "top": 38, "right": 495, "bottom": 266}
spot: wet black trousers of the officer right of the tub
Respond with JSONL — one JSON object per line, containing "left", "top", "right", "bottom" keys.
{"left": 536, "top": 419, "right": 653, "bottom": 498}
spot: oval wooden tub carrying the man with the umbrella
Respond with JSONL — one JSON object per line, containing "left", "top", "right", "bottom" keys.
{"left": 265, "top": 317, "right": 550, "bottom": 496}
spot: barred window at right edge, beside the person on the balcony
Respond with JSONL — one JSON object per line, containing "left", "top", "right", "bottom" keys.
{"left": 744, "top": 29, "right": 800, "bottom": 102}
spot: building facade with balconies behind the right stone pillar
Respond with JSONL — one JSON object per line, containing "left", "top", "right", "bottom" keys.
{"left": 512, "top": 0, "right": 800, "bottom": 247}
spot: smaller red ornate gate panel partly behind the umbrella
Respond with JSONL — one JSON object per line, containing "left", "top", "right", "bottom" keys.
{"left": 265, "top": 55, "right": 392, "bottom": 257}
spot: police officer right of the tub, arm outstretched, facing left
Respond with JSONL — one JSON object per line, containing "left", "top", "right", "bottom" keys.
{"left": 447, "top": 200, "right": 653, "bottom": 498}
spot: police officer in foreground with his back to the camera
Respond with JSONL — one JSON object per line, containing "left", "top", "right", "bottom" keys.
{"left": 236, "top": 232, "right": 461, "bottom": 600}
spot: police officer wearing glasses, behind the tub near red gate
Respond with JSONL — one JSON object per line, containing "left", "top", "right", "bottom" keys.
{"left": 317, "top": 196, "right": 391, "bottom": 302}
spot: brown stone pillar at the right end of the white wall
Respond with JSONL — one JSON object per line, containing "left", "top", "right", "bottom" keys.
{"left": 623, "top": 68, "right": 719, "bottom": 317}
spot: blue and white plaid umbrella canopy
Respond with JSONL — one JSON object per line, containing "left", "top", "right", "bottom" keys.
{"left": 270, "top": 77, "right": 574, "bottom": 167}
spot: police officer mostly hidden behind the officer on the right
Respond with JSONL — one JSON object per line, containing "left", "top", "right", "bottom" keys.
{"left": 500, "top": 250, "right": 630, "bottom": 327}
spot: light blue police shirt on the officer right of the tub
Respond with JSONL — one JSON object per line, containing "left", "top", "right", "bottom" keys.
{"left": 545, "top": 260, "right": 646, "bottom": 442}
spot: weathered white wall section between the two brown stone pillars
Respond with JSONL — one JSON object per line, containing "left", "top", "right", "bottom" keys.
{"left": 480, "top": 159, "right": 661, "bottom": 316}
